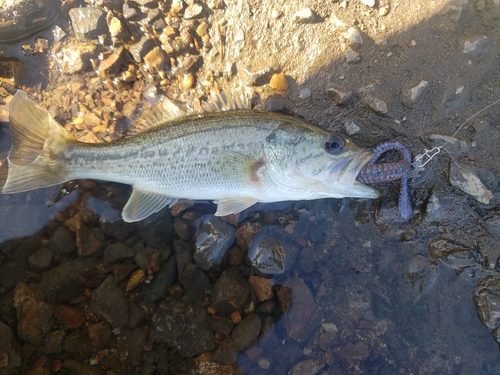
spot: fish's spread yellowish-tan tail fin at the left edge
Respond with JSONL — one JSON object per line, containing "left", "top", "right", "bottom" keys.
{"left": 0, "top": 90, "right": 74, "bottom": 194}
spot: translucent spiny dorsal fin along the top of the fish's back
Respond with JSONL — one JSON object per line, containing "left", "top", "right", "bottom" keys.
{"left": 125, "top": 88, "right": 252, "bottom": 138}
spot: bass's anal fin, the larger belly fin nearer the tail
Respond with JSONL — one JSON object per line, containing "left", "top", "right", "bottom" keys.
{"left": 122, "top": 187, "right": 177, "bottom": 223}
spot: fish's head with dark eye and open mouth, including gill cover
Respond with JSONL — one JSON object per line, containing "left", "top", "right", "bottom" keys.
{"left": 263, "top": 122, "right": 379, "bottom": 199}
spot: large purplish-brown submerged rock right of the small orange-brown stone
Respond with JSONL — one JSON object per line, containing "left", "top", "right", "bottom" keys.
{"left": 278, "top": 277, "right": 320, "bottom": 342}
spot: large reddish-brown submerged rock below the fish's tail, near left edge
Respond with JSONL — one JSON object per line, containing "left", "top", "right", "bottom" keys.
{"left": 14, "top": 283, "right": 54, "bottom": 345}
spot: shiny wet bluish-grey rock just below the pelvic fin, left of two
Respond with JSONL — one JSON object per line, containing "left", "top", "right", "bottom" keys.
{"left": 193, "top": 215, "right": 236, "bottom": 271}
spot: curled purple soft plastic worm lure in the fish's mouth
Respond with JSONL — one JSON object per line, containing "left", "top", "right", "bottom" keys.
{"left": 356, "top": 142, "right": 413, "bottom": 219}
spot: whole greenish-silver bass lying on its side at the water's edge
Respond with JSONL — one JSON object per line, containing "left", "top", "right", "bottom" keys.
{"left": 0, "top": 90, "right": 379, "bottom": 222}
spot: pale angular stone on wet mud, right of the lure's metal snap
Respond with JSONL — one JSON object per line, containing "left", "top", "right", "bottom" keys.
{"left": 450, "top": 163, "right": 494, "bottom": 204}
